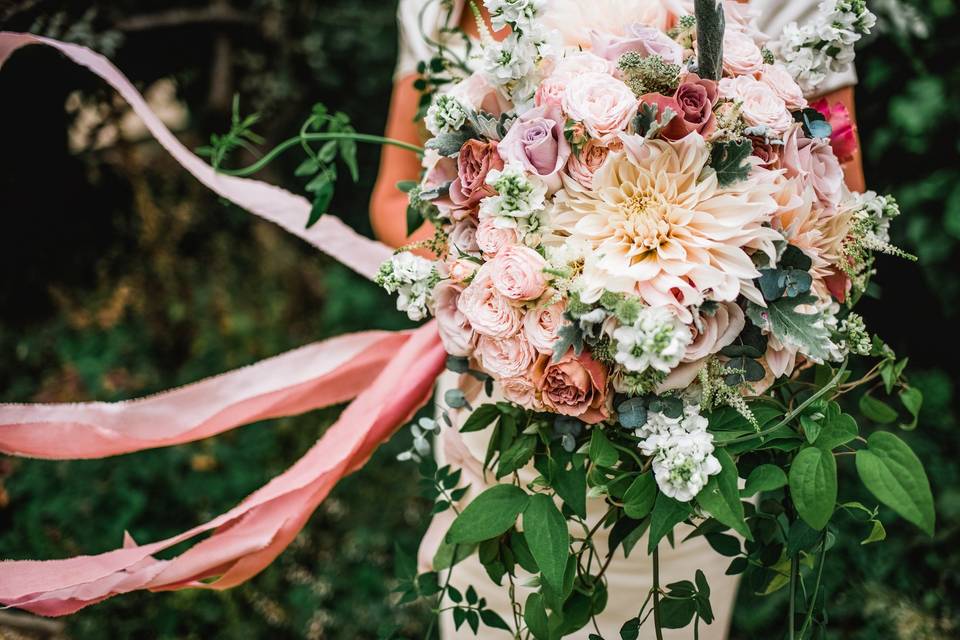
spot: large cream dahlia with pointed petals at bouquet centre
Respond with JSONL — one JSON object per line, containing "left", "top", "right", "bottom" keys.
{"left": 550, "top": 133, "right": 781, "bottom": 322}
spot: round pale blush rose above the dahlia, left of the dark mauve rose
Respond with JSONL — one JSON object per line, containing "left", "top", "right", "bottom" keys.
{"left": 563, "top": 73, "right": 638, "bottom": 143}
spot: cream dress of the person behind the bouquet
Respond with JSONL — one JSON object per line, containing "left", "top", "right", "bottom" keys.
{"left": 395, "top": 0, "right": 856, "bottom": 640}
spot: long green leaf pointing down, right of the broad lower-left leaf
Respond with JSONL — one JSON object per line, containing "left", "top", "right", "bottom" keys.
{"left": 523, "top": 493, "right": 570, "bottom": 591}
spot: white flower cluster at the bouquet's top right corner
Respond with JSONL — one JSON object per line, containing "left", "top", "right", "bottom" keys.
{"left": 776, "top": 0, "right": 877, "bottom": 93}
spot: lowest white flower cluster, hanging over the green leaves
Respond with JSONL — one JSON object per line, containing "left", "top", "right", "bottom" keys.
{"left": 636, "top": 404, "right": 721, "bottom": 502}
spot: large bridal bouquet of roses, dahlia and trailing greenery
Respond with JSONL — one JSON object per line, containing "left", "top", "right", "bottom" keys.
{"left": 378, "top": 0, "right": 934, "bottom": 639}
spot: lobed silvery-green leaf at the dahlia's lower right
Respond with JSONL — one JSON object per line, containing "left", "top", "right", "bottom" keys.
{"left": 747, "top": 294, "right": 831, "bottom": 360}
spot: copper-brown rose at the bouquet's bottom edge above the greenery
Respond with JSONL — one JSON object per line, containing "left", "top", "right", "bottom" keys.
{"left": 531, "top": 351, "right": 610, "bottom": 424}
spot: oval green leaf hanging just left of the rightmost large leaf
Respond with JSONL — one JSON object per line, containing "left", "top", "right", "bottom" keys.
{"left": 790, "top": 447, "right": 837, "bottom": 530}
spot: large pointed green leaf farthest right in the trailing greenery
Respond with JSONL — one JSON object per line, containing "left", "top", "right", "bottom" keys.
{"left": 857, "top": 431, "right": 936, "bottom": 536}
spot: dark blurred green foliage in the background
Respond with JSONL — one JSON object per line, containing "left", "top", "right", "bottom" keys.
{"left": 0, "top": 0, "right": 960, "bottom": 639}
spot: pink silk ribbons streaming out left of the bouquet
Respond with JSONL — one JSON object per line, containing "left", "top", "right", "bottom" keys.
{"left": 0, "top": 32, "right": 446, "bottom": 616}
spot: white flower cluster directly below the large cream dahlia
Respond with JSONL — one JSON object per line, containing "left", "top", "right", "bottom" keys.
{"left": 613, "top": 307, "right": 693, "bottom": 373}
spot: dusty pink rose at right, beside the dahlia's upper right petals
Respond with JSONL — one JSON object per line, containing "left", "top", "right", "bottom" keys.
{"left": 780, "top": 125, "right": 843, "bottom": 208}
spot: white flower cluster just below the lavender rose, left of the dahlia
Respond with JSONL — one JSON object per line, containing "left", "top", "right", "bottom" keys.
{"left": 480, "top": 164, "right": 547, "bottom": 244}
